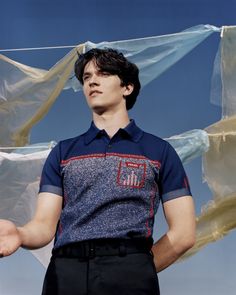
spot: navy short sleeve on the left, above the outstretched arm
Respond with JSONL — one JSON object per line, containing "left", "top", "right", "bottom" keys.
{"left": 39, "top": 144, "right": 63, "bottom": 196}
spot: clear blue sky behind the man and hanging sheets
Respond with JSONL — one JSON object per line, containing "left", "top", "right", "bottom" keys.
{"left": 0, "top": 0, "right": 236, "bottom": 295}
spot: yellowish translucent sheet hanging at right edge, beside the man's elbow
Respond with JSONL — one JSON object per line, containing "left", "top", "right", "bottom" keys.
{"left": 182, "top": 116, "right": 236, "bottom": 259}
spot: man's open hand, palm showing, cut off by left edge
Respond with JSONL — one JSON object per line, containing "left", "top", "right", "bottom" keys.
{"left": 0, "top": 219, "right": 21, "bottom": 257}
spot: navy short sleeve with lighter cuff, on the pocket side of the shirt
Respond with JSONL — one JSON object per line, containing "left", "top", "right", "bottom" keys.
{"left": 159, "top": 142, "right": 191, "bottom": 202}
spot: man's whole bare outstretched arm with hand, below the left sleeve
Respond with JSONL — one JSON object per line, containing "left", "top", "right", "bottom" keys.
{"left": 0, "top": 193, "right": 63, "bottom": 257}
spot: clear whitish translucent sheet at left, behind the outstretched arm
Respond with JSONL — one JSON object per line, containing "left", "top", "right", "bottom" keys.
{"left": 0, "top": 142, "right": 55, "bottom": 267}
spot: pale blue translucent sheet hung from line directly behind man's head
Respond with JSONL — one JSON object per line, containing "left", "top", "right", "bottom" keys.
{"left": 67, "top": 25, "right": 220, "bottom": 90}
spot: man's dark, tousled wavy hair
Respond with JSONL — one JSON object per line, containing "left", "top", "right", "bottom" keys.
{"left": 74, "top": 48, "right": 141, "bottom": 110}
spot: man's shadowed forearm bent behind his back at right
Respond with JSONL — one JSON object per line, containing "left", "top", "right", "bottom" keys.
{"left": 152, "top": 232, "right": 194, "bottom": 272}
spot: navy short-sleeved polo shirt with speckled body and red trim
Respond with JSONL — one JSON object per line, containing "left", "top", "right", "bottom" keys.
{"left": 40, "top": 120, "right": 191, "bottom": 248}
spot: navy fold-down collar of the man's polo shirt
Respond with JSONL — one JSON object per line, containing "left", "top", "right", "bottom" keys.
{"left": 84, "top": 119, "right": 143, "bottom": 144}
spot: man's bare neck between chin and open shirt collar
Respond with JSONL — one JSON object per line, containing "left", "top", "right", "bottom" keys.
{"left": 93, "top": 111, "right": 130, "bottom": 138}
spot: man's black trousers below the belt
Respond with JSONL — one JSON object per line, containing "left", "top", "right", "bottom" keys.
{"left": 42, "top": 252, "right": 160, "bottom": 295}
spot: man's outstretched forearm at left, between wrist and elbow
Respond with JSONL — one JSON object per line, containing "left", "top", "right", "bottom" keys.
{"left": 17, "top": 220, "right": 55, "bottom": 250}
